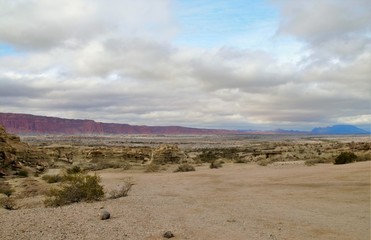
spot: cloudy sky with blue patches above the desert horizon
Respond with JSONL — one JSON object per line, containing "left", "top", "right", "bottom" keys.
{"left": 0, "top": 0, "right": 371, "bottom": 130}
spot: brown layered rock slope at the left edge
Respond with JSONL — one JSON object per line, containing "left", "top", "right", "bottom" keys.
{"left": 0, "top": 125, "right": 48, "bottom": 176}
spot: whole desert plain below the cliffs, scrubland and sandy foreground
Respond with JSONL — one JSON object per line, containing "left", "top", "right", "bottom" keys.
{"left": 0, "top": 136, "right": 371, "bottom": 240}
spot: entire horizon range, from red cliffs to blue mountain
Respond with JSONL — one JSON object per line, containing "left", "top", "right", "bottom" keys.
{"left": 0, "top": 113, "right": 369, "bottom": 135}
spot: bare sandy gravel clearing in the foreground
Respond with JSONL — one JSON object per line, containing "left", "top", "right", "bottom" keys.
{"left": 0, "top": 162, "right": 371, "bottom": 240}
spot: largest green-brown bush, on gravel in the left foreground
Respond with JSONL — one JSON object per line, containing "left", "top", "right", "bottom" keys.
{"left": 44, "top": 173, "right": 104, "bottom": 207}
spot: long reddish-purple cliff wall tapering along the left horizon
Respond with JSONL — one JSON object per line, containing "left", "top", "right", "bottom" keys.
{"left": 0, "top": 113, "right": 238, "bottom": 135}
